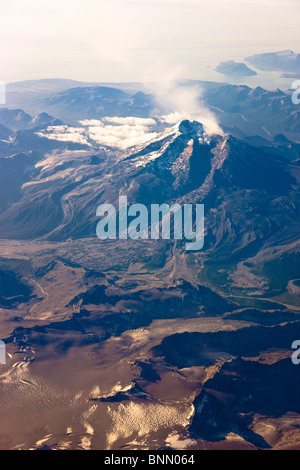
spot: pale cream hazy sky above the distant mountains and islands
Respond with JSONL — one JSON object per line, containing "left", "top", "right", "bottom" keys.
{"left": 0, "top": 0, "right": 300, "bottom": 82}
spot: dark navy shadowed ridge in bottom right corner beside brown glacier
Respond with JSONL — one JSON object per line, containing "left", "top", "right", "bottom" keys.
{"left": 190, "top": 359, "right": 300, "bottom": 448}
